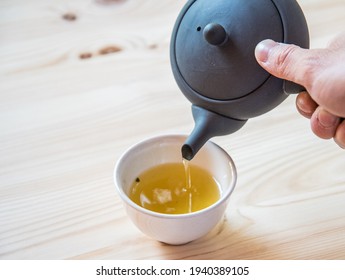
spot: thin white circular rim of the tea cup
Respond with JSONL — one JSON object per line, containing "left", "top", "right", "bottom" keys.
{"left": 113, "top": 134, "right": 237, "bottom": 219}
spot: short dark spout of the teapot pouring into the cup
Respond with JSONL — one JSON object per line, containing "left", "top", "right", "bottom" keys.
{"left": 181, "top": 105, "right": 247, "bottom": 160}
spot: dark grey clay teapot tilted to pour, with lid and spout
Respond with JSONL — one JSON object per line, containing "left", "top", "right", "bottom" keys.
{"left": 170, "top": 0, "right": 309, "bottom": 160}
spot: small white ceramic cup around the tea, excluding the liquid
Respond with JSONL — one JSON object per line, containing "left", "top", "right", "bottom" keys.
{"left": 114, "top": 135, "right": 237, "bottom": 245}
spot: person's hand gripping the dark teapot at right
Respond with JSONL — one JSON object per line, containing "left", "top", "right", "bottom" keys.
{"left": 255, "top": 33, "right": 345, "bottom": 149}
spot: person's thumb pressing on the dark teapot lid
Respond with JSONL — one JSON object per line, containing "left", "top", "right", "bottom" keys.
{"left": 255, "top": 39, "right": 310, "bottom": 88}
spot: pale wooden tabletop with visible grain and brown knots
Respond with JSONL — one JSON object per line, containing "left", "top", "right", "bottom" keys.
{"left": 0, "top": 0, "right": 345, "bottom": 259}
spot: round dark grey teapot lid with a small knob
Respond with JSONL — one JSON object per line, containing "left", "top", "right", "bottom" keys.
{"left": 172, "top": 0, "right": 284, "bottom": 100}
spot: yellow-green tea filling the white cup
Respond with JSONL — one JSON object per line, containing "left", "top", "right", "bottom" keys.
{"left": 129, "top": 160, "right": 220, "bottom": 214}
